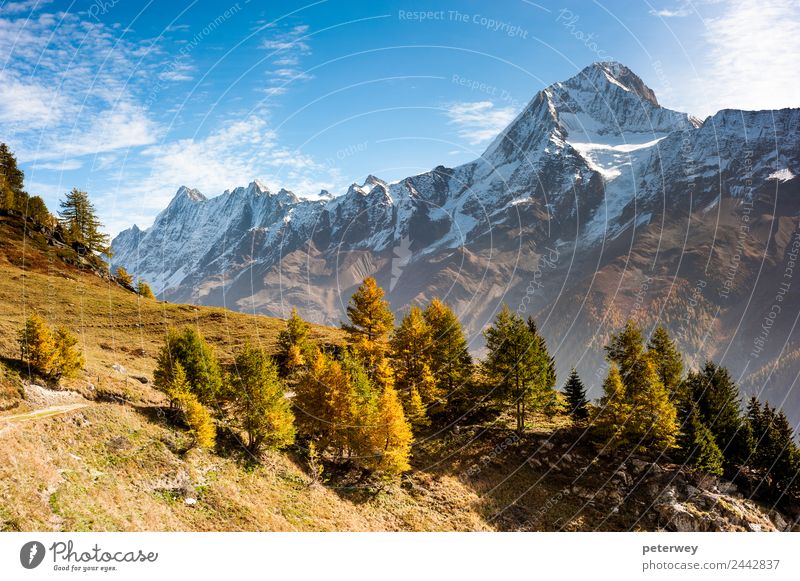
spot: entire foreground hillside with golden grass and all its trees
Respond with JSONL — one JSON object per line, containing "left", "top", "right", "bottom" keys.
{"left": 0, "top": 140, "right": 800, "bottom": 531}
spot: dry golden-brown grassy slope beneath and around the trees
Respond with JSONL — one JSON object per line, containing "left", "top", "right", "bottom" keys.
{"left": 0, "top": 217, "right": 792, "bottom": 531}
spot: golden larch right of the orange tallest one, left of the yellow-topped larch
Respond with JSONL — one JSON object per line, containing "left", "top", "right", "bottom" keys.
{"left": 390, "top": 306, "right": 441, "bottom": 423}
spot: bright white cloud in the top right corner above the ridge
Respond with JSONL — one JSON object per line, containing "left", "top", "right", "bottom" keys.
{"left": 690, "top": 0, "right": 800, "bottom": 115}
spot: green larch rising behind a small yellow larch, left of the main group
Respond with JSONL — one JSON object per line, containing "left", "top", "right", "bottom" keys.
{"left": 153, "top": 326, "right": 222, "bottom": 406}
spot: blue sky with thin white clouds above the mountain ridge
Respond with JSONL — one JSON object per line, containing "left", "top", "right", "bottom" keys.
{"left": 0, "top": 0, "right": 800, "bottom": 233}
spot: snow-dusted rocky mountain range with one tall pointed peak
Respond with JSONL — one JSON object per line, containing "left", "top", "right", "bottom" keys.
{"left": 112, "top": 62, "right": 800, "bottom": 424}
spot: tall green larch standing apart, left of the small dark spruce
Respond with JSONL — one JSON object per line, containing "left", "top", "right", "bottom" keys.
{"left": 484, "top": 305, "right": 550, "bottom": 433}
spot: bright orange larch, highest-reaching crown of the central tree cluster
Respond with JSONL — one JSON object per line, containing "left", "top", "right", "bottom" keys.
{"left": 342, "top": 277, "right": 394, "bottom": 376}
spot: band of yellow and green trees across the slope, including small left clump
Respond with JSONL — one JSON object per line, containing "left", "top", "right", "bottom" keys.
{"left": 19, "top": 278, "right": 800, "bottom": 495}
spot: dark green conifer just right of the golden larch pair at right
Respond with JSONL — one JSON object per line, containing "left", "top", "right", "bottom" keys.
{"left": 686, "top": 361, "right": 753, "bottom": 466}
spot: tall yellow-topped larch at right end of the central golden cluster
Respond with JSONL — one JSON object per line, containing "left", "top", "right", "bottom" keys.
{"left": 424, "top": 298, "right": 473, "bottom": 405}
